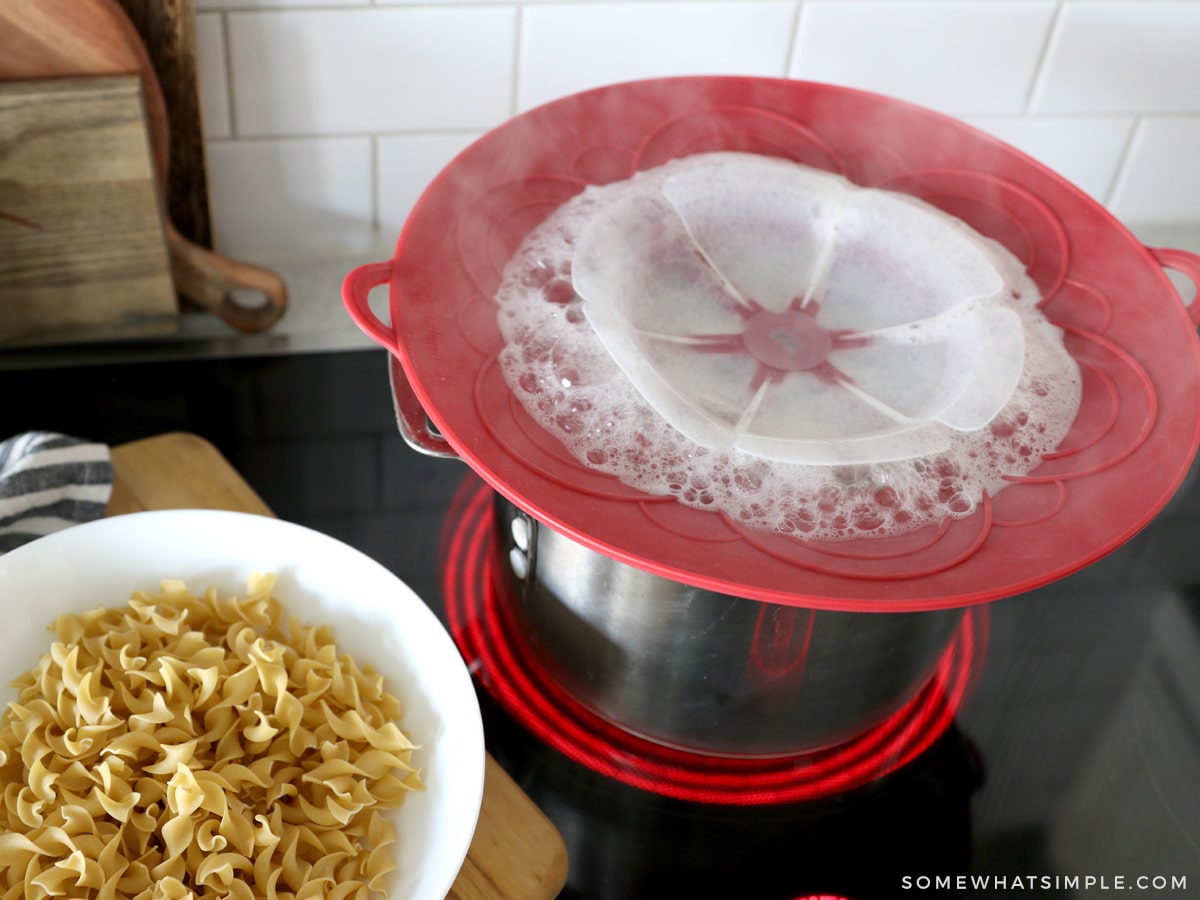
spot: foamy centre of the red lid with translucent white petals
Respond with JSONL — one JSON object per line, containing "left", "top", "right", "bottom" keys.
{"left": 497, "top": 154, "right": 1081, "bottom": 539}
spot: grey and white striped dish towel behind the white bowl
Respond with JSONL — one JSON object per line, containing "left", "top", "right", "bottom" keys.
{"left": 0, "top": 431, "right": 113, "bottom": 553}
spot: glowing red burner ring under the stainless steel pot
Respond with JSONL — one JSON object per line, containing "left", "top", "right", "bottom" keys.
{"left": 442, "top": 478, "right": 988, "bottom": 806}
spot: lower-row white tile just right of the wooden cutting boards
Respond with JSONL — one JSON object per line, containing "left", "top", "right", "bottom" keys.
{"left": 208, "top": 138, "right": 374, "bottom": 258}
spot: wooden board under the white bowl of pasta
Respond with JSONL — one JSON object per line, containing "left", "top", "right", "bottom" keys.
{"left": 108, "top": 433, "right": 566, "bottom": 900}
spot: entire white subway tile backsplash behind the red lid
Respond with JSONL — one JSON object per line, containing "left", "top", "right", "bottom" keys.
{"left": 194, "top": 0, "right": 1200, "bottom": 247}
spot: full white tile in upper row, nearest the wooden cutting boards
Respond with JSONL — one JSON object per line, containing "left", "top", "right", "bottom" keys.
{"left": 227, "top": 6, "right": 516, "bottom": 136}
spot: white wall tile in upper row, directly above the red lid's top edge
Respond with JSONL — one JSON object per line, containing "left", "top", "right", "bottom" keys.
{"left": 517, "top": 0, "right": 796, "bottom": 109}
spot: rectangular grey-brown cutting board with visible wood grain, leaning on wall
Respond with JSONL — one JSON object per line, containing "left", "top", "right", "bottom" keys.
{"left": 0, "top": 76, "right": 178, "bottom": 344}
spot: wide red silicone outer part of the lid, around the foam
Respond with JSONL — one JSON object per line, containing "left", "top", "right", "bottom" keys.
{"left": 344, "top": 77, "right": 1200, "bottom": 611}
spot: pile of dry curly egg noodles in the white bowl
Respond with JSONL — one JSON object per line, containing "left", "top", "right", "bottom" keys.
{"left": 0, "top": 575, "right": 422, "bottom": 900}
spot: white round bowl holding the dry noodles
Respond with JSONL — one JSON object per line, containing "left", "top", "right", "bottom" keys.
{"left": 0, "top": 510, "right": 485, "bottom": 900}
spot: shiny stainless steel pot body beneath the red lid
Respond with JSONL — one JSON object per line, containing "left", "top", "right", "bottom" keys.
{"left": 496, "top": 494, "right": 962, "bottom": 756}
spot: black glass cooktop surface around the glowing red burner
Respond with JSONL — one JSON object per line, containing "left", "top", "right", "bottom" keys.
{"left": 9, "top": 352, "right": 1200, "bottom": 900}
